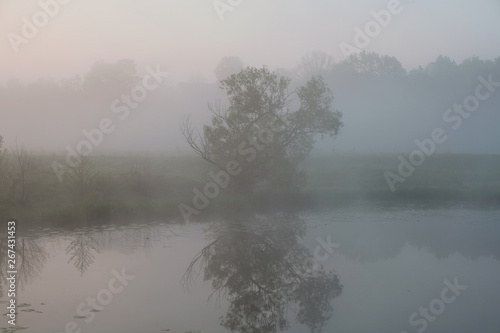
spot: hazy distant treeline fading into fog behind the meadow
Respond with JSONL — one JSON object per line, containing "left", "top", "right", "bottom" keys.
{"left": 0, "top": 51, "right": 500, "bottom": 154}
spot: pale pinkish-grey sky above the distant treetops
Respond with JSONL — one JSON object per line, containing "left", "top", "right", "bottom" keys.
{"left": 0, "top": 0, "right": 500, "bottom": 82}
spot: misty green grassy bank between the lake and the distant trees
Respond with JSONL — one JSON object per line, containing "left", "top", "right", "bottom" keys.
{"left": 0, "top": 153, "right": 500, "bottom": 226}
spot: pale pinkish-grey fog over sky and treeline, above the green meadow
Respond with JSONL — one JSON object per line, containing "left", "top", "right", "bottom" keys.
{"left": 0, "top": 0, "right": 500, "bottom": 154}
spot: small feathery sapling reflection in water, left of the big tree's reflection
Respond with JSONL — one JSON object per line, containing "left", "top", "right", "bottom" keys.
{"left": 66, "top": 234, "right": 99, "bottom": 276}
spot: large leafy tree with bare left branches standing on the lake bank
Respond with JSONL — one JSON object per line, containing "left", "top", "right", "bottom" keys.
{"left": 181, "top": 67, "right": 343, "bottom": 192}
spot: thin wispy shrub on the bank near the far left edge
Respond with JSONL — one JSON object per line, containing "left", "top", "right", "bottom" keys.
{"left": 8, "top": 142, "right": 41, "bottom": 204}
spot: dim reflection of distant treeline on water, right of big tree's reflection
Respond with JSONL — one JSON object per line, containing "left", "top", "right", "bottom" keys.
{"left": 309, "top": 210, "right": 500, "bottom": 264}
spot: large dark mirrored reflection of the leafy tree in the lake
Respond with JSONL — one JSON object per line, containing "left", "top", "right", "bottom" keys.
{"left": 183, "top": 216, "right": 342, "bottom": 332}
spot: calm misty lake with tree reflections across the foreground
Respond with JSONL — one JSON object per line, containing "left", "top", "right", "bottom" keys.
{"left": 0, "top": 207, "right": 500, "bottom": 333}
